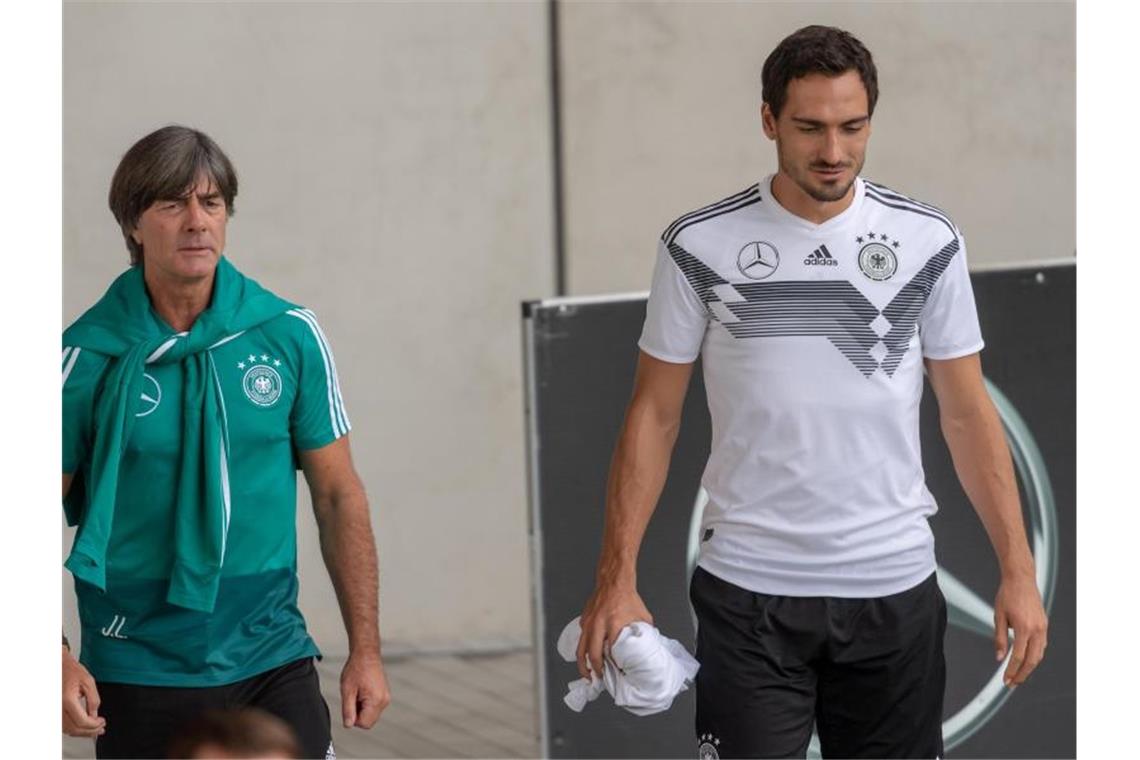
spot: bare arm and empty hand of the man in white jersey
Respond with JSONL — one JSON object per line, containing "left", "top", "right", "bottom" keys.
{"left": 926, "top": 353, "right": 1049, "bottom": 686}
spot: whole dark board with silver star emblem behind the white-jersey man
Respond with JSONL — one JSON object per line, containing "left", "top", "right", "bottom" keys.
{"left": 524, "top": 265, "right": 1076, "bottom": 758}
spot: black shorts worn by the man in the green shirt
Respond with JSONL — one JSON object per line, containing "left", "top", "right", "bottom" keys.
{"left": 95, "top": 657, "right": 332, "bottom": 758}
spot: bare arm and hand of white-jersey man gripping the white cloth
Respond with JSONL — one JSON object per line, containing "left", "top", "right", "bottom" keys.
{"left": 578, "top": 351, "right": 693, "bottom": 678}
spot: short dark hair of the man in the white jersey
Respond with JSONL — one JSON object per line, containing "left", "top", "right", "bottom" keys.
{"left": 760, "top": 25, "right": 879, "bottom": 119}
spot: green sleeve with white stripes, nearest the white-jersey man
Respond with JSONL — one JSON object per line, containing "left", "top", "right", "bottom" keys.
{"left": 288, "top": 309, "right": 351, "bottom": 450}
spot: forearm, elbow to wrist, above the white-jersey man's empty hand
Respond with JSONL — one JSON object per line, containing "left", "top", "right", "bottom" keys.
{"left": 942, "top": 398, "right": 1034, "bottom": 575}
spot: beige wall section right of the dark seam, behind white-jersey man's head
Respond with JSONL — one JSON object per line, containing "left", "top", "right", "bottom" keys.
{"left": 560, "top": 2, "right": 1076, "bottom": 294}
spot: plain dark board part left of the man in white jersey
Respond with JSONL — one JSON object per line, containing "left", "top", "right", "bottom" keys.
{"left": 524, "top": 296, "right": 709, "bottom": 758}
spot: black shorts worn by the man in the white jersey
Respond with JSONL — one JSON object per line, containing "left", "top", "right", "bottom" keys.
{"left": 690, "top": 567, "right": 946, "bottom": 758}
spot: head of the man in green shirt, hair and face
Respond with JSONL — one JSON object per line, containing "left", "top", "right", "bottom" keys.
{"left": 107, "top": 125, "right": 237, "bottom": 280}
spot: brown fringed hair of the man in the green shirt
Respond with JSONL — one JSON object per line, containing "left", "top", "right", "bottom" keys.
{"left": 107, "top": 124, "right": 237, "bottom": 267}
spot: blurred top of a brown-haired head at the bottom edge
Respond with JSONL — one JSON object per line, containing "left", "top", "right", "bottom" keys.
{"left": 168, "top": 708, "right": 301, "bottom": 760}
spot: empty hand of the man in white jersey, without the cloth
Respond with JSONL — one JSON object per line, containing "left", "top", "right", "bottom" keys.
{"left": 994, "top": 573, "right": 1049, "bottom": 688}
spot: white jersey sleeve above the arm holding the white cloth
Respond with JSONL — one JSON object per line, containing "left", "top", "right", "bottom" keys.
{"left": 637, "top": 242, "right": 709, "bottom": 365}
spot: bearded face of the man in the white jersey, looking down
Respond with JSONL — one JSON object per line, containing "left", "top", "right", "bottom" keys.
{"left": 760, "top": 71, "right": 871, "bottom": 203}
